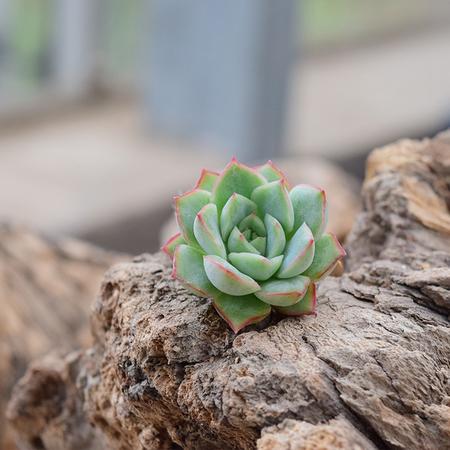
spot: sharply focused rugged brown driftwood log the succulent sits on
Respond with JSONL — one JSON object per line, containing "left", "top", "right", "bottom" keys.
{"left": 8, "top": 135, "right": 450, "bottom": 450}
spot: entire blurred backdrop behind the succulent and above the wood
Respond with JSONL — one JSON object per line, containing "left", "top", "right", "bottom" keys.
{"left": 0, "top": 0, "right": 450, "bottom": 253}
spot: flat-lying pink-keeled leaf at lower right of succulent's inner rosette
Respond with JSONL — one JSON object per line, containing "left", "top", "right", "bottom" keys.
{"left": 255, "top": 275, "right": 310, "bottom": 306}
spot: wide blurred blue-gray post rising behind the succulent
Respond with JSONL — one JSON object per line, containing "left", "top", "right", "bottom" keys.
{"left": 144, "top": 0, "right": 295, "bottom": 161}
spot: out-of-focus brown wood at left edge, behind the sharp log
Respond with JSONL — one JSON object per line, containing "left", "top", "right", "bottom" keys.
{"left": 0, "top": 224, "right": 123, "bottom": 449}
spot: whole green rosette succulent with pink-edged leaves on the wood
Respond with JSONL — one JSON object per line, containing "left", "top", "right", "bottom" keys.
{"left": 163, "top": 158, "right": 345, "bottom": 333}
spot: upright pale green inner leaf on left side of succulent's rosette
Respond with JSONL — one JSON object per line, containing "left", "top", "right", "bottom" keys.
{"left": 194, "top": 203, "right": 227, "bottom": 258}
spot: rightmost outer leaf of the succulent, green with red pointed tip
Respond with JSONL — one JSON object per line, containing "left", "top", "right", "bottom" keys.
{"left": 303, "top": 233, "right": 346, "bottom": 281}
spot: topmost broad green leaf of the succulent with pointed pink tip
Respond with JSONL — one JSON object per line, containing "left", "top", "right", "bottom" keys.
{"left": 211, "top": 159, "right": 266, "bottom": 212}
